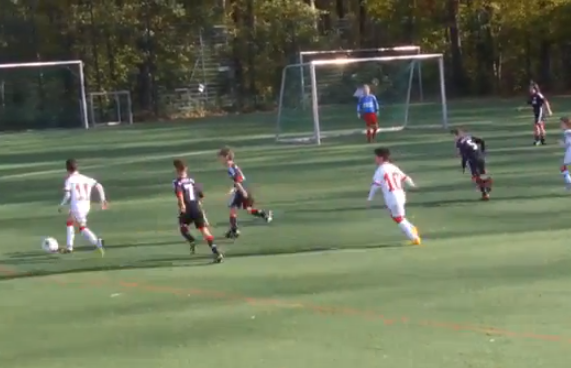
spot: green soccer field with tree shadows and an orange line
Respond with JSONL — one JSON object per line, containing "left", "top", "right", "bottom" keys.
{"left": 0, "top": 99, "right": 571, "bottom": 368}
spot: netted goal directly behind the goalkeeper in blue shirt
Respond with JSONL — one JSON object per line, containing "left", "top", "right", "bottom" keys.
{"left": 276, "top": 54, "right": 448, "bottom": 144}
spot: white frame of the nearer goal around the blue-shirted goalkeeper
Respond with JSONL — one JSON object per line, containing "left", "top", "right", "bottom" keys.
{"left": 276, "top": 54, "right": 448, "bottom": 145}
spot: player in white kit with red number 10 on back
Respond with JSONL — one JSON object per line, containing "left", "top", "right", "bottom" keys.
{"left": 368, "top": 148, "right": 421, "bottom": 245}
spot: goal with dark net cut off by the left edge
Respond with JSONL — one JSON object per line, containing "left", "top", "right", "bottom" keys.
{"left": 0, "top": 60, "right": 89, "bottom": 130}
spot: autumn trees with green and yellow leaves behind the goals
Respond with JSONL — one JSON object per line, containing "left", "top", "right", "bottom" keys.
{"left": 0, "top": 0, "right": 571, "bottom": 123}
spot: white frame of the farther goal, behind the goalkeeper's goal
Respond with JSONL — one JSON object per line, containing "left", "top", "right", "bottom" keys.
{"left": 297, "top": 45, "right": 423, "bottom": 101}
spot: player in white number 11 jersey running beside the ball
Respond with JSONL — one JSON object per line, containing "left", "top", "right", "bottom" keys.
{"left": 59, "top": 159, "right": 107, "bottom": 255}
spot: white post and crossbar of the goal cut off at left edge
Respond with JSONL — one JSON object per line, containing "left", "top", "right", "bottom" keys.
{"left": 0, "top": 60, "right": 89, "bottom": 129}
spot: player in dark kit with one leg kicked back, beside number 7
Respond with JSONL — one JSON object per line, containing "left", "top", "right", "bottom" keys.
{"left": 218, "top": 147, "right": 273, "bottom": 239}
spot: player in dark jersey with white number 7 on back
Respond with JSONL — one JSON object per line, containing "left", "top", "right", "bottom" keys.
{"left": 173, "top": 160, "right": 224, "bottom": 263}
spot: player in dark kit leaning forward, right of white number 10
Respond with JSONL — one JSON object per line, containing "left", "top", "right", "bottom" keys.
{"left": 451, "top": 129, "right": 492, "bottom": 201}
